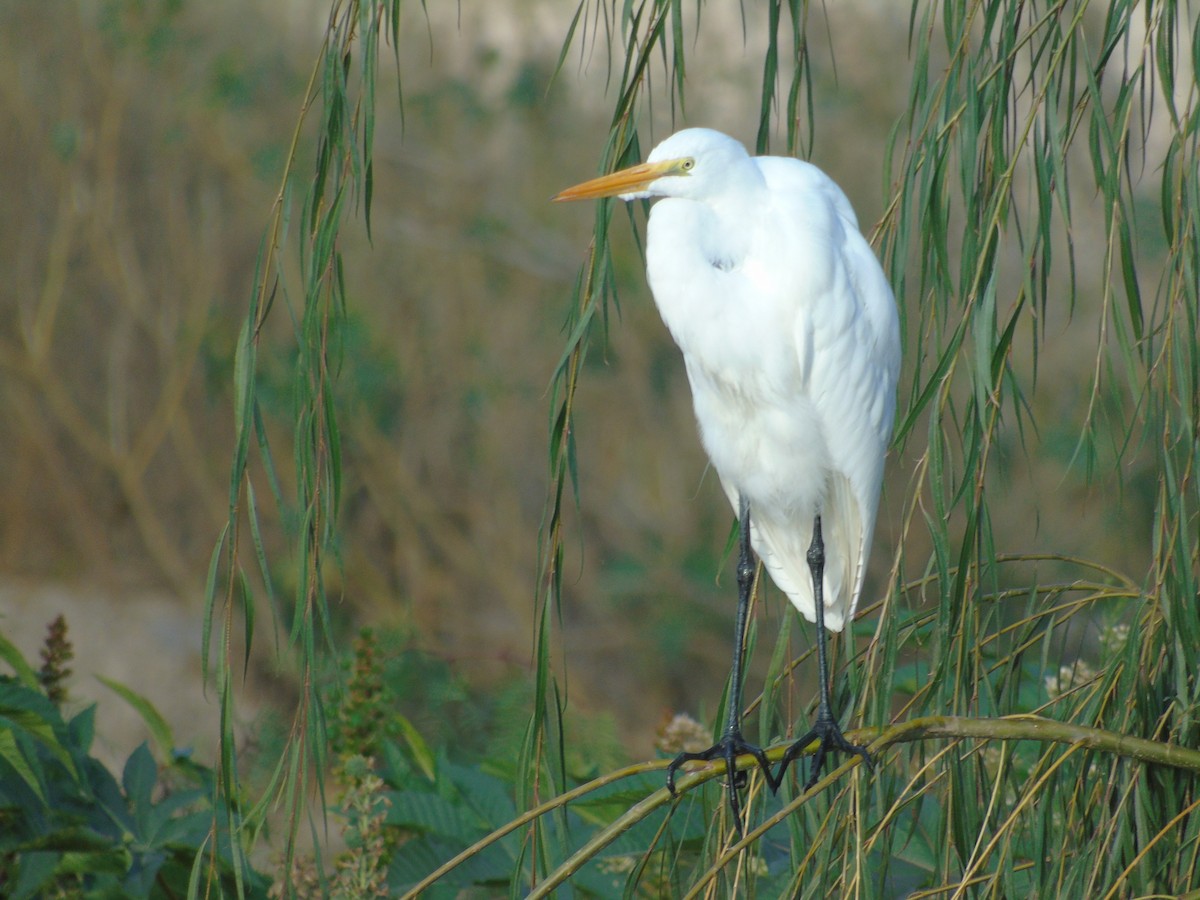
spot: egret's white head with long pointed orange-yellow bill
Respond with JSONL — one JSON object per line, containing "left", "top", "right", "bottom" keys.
{"left": 554, "top": 128, "right": 752, "bottom": 200}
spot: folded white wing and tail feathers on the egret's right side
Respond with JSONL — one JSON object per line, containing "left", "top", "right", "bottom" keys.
{"left": 751, "top": 157, "right": 900, "bottom": 630}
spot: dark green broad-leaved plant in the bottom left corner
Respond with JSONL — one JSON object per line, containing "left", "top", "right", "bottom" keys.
{"left": 0, "top": 617, "right": 266, "bottom": 899}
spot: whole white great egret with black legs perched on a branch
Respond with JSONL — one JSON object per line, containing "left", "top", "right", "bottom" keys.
{"left": 554, "top": 128, "right": 900, "bottom": 830}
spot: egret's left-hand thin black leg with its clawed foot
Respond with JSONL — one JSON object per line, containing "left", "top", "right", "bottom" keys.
{"left": 667, "top": 498, "right": 776, "bottom": 834}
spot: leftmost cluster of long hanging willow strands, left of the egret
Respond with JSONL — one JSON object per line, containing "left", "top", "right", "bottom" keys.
{"left": 203, "top": 0, "right": 410, "bottom": 888}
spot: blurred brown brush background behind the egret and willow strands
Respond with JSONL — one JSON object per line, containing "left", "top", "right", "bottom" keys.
{"left": 0, "top": 0, "right": 1154, "bottom": 772}
